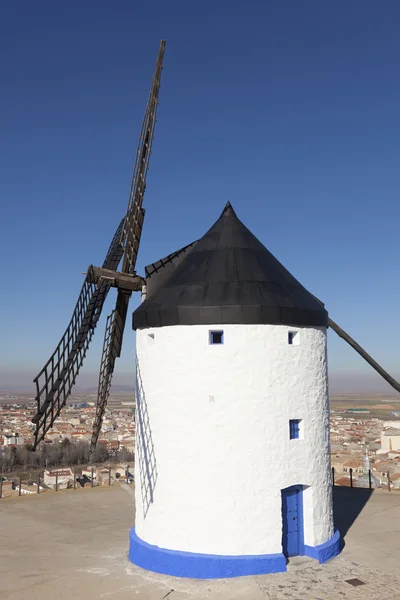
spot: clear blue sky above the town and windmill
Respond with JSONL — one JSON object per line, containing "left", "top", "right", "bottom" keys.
{"left": 0, "top": 0, "right": 400, "bottom": 389}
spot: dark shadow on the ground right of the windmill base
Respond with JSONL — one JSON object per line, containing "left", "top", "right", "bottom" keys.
{"left": 333, "top": 486, "right": 373, "bottom": 548}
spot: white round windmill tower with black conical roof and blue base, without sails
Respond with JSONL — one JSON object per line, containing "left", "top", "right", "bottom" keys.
{"left": 129, "top": 204, "right": 339, "bottom": 578}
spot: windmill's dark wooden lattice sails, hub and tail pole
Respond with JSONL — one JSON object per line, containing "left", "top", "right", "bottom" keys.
{"left": 32, "top": 40, "right": 400, "bottom": 464}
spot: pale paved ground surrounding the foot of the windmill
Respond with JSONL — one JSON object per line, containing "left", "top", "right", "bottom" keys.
{"left": 0, "top": 484, "right": 400, "bottom": 600}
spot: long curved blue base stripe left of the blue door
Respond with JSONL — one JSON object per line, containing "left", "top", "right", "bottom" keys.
{"left": 129, "top": 527, "right": 286, "bottom": 579}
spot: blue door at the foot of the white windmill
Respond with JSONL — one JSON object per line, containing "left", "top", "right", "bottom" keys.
{"left": 282, "top": 486, "right": 304, "bottom": 557}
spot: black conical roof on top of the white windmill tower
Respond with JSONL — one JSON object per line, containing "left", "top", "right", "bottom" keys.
{"left": 133, "top": 202, "right": 328, "bottom": 329}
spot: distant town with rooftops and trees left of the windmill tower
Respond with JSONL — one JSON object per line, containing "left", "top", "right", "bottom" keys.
{"left": 0, "top": 392, "right": 135, "bottom": 498}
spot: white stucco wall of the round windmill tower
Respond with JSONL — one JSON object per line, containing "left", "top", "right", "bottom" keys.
{"left": 136, "top": 325, "right": 333, "bottom": 555}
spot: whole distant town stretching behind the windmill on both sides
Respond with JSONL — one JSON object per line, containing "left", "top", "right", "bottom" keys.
{"left": 0, "top": 391, "right": 400, "bottom": 497}
